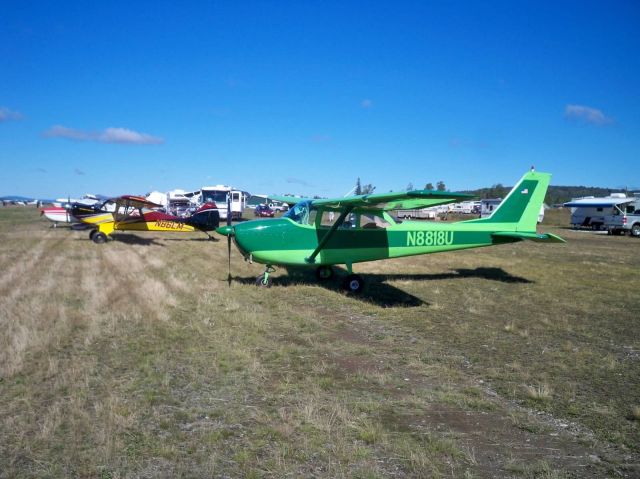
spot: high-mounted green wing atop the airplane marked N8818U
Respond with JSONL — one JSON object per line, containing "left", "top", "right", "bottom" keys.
{"left": 269, "top": 190, "right": 477, "bottom": 211}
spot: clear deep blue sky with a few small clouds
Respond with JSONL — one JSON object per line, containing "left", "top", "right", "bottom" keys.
{"left": 0, "top": 1, "right": 640, "bottom": 198}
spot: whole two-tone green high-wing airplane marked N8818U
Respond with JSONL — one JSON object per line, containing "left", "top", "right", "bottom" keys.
{"left": 216, "top": 169, "right": 564, "bottom": 293}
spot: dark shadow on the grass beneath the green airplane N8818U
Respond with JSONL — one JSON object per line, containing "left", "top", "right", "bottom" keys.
{"left": 232, "top": 267, "right": 532, "bottom": 308}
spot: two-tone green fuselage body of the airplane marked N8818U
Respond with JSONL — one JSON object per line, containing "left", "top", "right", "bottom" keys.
{"left": 234, "top": 218, "right": 518, "bottom": 265}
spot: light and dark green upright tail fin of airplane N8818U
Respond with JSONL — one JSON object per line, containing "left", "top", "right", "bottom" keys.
{"left": 472, "top": 170, "right": 551, "bottom": 233}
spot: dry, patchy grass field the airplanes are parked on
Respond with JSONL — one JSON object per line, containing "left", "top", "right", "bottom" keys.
{"left": 0, "top": 207, "right": 640, "bottom": 478}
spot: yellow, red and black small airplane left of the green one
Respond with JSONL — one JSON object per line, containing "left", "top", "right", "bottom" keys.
{"left": 71, "top": 195, "right": 220, "bottom": 244}
